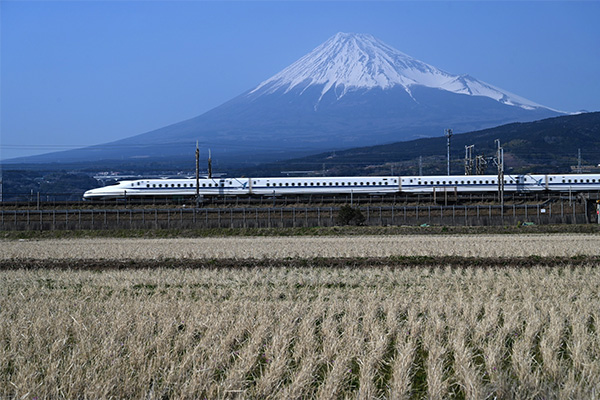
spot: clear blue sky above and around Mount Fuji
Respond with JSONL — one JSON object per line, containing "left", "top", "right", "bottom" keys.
{"left": 0, "top": 0, "right": 600, "bottom": 159}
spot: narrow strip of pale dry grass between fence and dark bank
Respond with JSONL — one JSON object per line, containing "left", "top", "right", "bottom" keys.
{"left": 0, "top": 234, "right": 600, "bottom": 260}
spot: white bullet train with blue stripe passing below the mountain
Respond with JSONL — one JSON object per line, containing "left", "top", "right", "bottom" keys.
{"left": 83, "top": 174, "right": 600, "bottom": 200}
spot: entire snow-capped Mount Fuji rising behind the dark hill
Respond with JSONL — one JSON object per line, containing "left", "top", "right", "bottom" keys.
{"left": 12, "top": 33, "right": 563, "bottom": 163}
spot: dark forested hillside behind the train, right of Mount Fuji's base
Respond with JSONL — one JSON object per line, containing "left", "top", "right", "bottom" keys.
{"left": 244, "top": 112, "right": 600, "bottom": 175}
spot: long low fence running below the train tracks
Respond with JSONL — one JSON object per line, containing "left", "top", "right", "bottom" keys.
{"left": 0, "top": 201, "right": 596, "bottom": 231}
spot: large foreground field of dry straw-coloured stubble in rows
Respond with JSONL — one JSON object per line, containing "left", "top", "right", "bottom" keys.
{"left": 0, "top": 265, "right": 600, "bottom": 399}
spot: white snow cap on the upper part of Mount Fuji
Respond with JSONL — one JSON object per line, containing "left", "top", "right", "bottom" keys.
{"left": 250, "top": 33, "right": 544, "bottom": 109}
